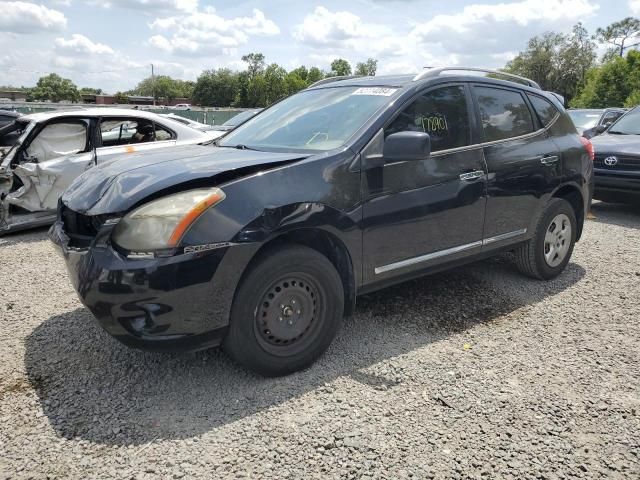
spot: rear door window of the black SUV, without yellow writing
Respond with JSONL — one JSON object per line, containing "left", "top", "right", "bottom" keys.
{"left": 474, "top": 87, "right": 533, "bottom": 142}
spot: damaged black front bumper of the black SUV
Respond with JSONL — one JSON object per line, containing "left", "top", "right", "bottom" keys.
{"left": 49, "top": 214, "right": 257, "bottom": 351}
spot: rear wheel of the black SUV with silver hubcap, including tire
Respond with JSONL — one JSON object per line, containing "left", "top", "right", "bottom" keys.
{"left": 515, "top": 198, "right": 578, "bottom": 280}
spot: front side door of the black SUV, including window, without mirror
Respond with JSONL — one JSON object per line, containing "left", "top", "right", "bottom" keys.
{"left": 363, "top": 84, "right": 486, "bottom": 283}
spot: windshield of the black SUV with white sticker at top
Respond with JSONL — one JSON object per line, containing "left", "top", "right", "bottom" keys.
{"left": 220, "top": 87, "right": 397, "bottom": 151}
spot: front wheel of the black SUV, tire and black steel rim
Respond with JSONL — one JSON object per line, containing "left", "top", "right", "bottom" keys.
{"left": 223, "top": 245, "right": 344, "bottom": 377}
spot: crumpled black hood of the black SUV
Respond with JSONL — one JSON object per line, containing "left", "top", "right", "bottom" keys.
{"left": 62, "top": 145, "right": 309, "bottom": 215}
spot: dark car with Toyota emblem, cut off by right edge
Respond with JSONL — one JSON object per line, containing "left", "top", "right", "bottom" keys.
{"left": 592, "top": 107, "right": 640, "bottom": 203}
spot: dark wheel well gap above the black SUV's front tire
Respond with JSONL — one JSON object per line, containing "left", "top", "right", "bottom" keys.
{"left": 247, "top": 228, "right": 356, "bottom": 316}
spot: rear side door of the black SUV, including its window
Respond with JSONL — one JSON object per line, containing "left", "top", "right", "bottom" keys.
{"left": 473, "top": 84, "right": 562, "bottom": 247}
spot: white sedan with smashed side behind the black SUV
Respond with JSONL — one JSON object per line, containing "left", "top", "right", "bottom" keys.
{"left": 0, "top": 108, "right": 219, "bottom": 235}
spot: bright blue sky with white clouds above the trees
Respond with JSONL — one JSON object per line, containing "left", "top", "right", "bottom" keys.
{"left": 0, "top": 0, "right": 640, "bottom": 93}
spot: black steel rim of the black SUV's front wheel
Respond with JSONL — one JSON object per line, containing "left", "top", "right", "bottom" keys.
{"left": 254, "top": 273, "right": 324, "bottom": 355}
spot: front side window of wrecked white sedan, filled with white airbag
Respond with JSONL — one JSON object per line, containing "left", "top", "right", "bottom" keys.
{"left": 26, "top": 121, "right": 89, "bottom": 162}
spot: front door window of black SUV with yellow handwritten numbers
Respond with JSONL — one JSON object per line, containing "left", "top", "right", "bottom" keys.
{"left": 385, "top": 85, "right": 471, "bottom": 152}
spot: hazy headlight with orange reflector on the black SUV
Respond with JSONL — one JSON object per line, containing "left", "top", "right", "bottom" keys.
{"left": 112, "top": 188, "right": 225, "bottom": 252}
